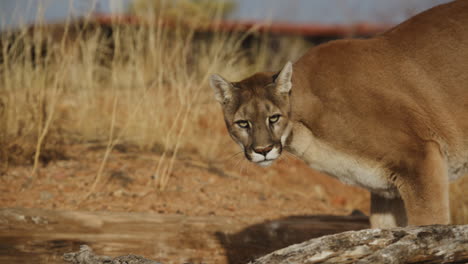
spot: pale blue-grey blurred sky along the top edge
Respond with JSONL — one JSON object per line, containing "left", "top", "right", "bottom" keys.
{"left": 0, "top": 0, "right": 449, "bottom": 30}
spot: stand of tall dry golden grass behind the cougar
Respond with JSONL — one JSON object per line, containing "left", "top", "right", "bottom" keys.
{"left": 0, "top": 3, "right": 307, "bottom": 190}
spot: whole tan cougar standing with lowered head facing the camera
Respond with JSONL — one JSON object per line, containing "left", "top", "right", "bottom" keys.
{"left": 210, "top": 0, "right": 468, "bottom": 228}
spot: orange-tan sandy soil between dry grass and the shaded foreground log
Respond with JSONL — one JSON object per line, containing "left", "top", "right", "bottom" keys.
{"left": 0, "top": 145, "right": 369, "bottom": 219}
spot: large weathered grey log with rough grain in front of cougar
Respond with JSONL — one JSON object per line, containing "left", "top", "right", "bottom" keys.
{"left": 250, "top": 225, "right": 468, "bottom": 264}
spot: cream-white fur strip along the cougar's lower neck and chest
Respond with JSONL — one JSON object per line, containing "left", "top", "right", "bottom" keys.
{"left": 288, "top": 125, "right": 397, "bottom": 198}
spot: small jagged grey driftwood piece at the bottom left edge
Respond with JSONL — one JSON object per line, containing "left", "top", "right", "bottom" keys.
{"left": 63, "top": 245, "right": 161, "bottom": 264}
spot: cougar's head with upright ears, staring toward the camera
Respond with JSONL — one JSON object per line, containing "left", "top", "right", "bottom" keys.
{"left": 210, "top": 62, "right": 292, "bottom": 167}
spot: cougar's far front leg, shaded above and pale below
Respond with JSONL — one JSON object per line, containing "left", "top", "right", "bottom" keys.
{"left": 370, "top": 193, "right": 407, "bottom": 228}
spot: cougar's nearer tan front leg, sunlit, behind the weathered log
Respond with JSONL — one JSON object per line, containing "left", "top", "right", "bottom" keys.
{"left": 397, "top": 142, "right": 450, "bottom": 225}
